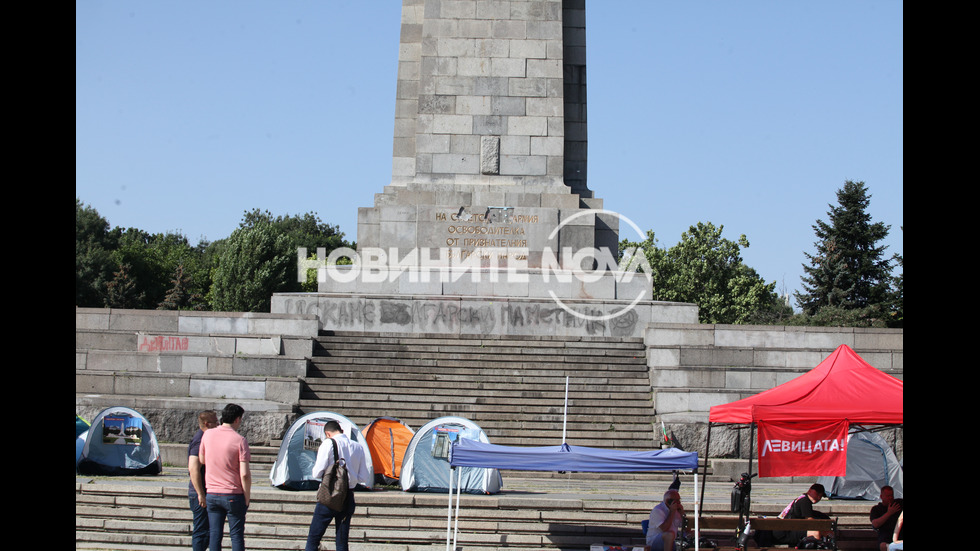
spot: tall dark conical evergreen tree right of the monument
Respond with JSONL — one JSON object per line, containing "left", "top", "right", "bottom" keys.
{"left": 795, "top": 181, "right": 892, "bottom": 325}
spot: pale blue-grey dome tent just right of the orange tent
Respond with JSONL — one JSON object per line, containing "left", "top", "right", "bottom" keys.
{"left": 399, "top": 417, "right": 503, "bottom": 494}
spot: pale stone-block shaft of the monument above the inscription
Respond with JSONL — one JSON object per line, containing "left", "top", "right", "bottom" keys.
{"left": 392, "top": 0, "right": 572, "bottom": 188}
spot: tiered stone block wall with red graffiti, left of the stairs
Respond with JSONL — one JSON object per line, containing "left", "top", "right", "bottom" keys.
{"left": 75, "top": 308, "right": 318, "bottom": 443}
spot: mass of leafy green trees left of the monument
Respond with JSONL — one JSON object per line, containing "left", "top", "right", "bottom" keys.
{"left": 75, "top": 198, "right": 353, "bottom": 311}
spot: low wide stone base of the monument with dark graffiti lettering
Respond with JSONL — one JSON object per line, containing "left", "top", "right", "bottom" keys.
{"left": 272, "top": 266, "right": 698, "bottom": 338}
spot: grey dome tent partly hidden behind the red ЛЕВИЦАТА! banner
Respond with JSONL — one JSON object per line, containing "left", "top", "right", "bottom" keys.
{"left": 817, "top": 430, "right": 904, "bottom": 501}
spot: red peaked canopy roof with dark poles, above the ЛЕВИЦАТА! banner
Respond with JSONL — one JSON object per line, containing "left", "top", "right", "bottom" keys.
{"left": 702, "top": 345, "right": 904, "bottom": 520}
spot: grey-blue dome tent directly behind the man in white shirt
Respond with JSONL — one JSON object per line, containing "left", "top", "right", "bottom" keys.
{"left": 269, "top": 411, "right": 374, "bottom": 490}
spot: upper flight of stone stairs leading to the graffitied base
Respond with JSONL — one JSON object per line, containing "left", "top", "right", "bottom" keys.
{"left": 299, "top": 333, "right": 659, "bottom": 449}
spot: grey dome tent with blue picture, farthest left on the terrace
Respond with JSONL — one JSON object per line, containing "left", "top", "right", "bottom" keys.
{"left": 75, "top": 406, "right": 163, "bottom": 476}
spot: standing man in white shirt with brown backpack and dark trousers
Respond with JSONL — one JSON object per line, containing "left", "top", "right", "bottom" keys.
{"left": 306, "top": 420, "right": 372, "bottom": 551}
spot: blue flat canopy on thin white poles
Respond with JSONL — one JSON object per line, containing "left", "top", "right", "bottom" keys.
{"left": 446, "top": 438, "right": 699, "bottom": 549}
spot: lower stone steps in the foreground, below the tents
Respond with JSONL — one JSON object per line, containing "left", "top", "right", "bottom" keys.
{"left": 75, "top": 467, "right": 872, "bottom": 551}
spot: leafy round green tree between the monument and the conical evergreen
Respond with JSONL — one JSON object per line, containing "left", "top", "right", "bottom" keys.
{"left": 620, "top": 222, "right": 781, "bottom": 323}
